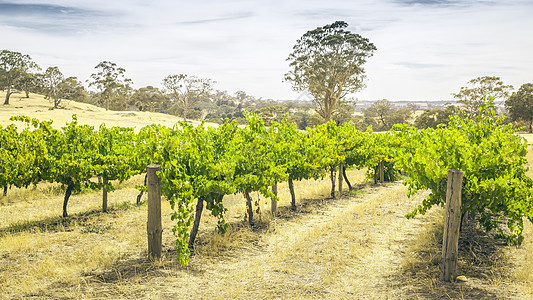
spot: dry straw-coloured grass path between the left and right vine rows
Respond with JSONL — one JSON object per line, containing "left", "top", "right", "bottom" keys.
{"left": 70, "top": 183, "right": 436, "bottom": 299}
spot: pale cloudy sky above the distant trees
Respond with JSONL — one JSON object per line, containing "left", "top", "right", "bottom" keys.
{"left": 0, "top": 0, "right": 533, "bottom": 101}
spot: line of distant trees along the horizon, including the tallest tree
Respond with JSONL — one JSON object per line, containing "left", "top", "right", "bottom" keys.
{"left": 0, "top": 47, "right": 533, "bottom": 132}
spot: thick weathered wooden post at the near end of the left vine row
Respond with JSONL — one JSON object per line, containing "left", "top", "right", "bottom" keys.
{"left": 146, "top": 165, "right": 163, "bottom": 259}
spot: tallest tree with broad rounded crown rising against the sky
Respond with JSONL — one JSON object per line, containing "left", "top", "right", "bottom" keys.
{"left": 285, "top": 21, "right": 376, "bottom": 122}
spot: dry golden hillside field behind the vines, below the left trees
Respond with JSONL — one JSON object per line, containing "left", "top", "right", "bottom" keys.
{"left": 0, "top": 91, "right": 212, "bottom": 129}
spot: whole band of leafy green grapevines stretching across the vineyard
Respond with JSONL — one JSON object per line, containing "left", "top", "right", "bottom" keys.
{"left": 0, "top": 107, "right": 533, "bottom": 265}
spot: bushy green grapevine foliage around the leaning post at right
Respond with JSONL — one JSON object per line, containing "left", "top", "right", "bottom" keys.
{"left": 396, "top": 106, "right": 533, "bottom": 243}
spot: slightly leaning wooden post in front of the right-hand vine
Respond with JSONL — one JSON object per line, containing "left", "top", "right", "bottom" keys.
{"left": 440, "top": 170, "right": 463, "bottom": 282}
